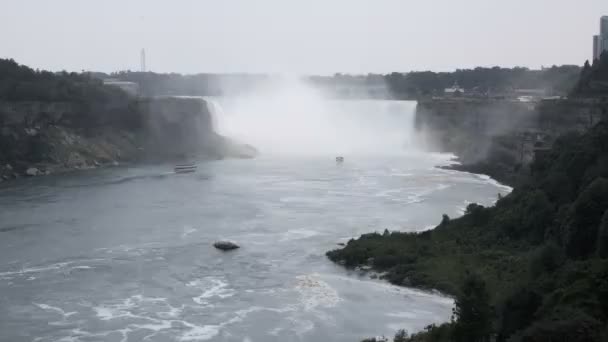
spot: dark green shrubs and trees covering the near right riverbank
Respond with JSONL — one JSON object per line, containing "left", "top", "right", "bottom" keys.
{"left": 327, "top": 122, "right": 608, "bottom": 341}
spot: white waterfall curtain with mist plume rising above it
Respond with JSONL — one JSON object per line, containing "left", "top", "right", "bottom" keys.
{"left": 209, "top": 80, "right": 416, "bottom": 156}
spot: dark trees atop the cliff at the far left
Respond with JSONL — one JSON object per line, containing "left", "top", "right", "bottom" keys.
{"left": 0, "top": 59, "right": 127, "bottom": 103}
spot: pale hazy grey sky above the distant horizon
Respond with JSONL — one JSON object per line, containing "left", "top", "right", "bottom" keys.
{"left": 0, "top": 0, "right": 608, "bottom": 74}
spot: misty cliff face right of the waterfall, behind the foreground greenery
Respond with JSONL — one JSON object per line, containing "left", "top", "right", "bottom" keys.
{"left": 415, "top": 98, "right": 608, "bottom": 184}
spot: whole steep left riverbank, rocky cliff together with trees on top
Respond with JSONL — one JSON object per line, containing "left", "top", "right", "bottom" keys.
{"left": 0, "top": 59, "right": 256, "bottom": 181}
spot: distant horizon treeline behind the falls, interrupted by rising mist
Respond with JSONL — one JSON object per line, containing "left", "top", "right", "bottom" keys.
{"left": 103, "top": 65, "right": 581, "bottom": 99}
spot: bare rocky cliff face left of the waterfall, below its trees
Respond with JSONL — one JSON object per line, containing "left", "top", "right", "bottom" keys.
{"left": 0, "top": 97, "right": 257, "bottom": 180}
